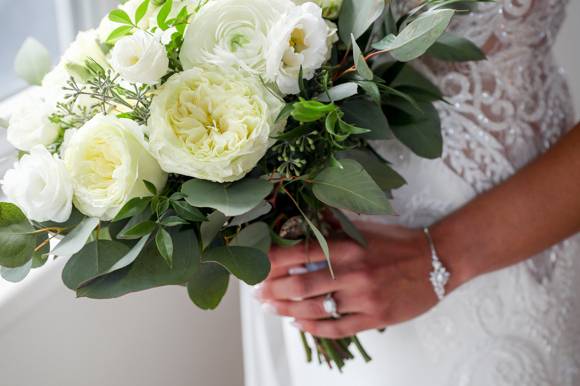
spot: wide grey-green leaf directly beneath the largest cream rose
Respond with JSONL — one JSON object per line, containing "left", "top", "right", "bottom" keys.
{"left": 181, "top": 178, "right": 273, "bottom": 217}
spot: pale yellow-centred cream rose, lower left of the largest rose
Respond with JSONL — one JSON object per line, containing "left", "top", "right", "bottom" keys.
{"left": 64, "top": 114, "right": 167, "bottom": 221}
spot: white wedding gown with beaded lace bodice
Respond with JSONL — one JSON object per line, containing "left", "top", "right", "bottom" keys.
{"left": 242, "top": 0, "right": 580, "bottom": 386}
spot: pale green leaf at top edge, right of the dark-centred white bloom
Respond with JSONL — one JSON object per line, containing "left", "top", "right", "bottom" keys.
{"left": 338, "top": 0, "right": 385, "bottom": 45}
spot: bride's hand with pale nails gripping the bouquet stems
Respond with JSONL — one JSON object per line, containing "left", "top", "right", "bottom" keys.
{"left": 256, "top": 224, "right": 458, "bottom": 338}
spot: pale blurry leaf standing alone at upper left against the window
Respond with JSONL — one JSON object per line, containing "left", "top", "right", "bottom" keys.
{"left": 14, "top": 38, "right": 52, "bottom": 86}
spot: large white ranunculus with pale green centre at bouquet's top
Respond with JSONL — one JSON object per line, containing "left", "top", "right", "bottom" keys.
{"left": 181, "top": 0, "right": 296, "bottom": 74}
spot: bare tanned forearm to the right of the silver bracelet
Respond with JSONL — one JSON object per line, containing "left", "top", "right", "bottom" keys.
{"left": 432, "top": 125, "right": 580, "bottom": 288}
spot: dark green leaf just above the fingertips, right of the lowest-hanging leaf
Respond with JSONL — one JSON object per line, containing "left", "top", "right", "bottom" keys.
{"left": 202, "top": 246, "right": 270, "bottom": 285}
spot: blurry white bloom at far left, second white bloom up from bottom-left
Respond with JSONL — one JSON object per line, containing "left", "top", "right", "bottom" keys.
{"left": 6, "top": 95, "right": 59, "bottom": 151}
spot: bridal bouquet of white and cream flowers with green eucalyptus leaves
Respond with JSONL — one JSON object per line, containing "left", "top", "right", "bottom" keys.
{"left": 0, "top": 0, "right": 483, "bottom": 368}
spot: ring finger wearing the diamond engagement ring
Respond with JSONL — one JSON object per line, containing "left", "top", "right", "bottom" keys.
{"left": 268, "top": 291, "right": 362, "bottom": 320}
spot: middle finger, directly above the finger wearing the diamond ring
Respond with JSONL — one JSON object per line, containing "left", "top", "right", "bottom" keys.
{"left": 258, "top": 270, "right": 342, "bottom": 301}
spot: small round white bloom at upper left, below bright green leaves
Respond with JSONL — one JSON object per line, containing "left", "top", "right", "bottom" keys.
{"left": 111, "top": 31, "right": 169, "bottom": 84}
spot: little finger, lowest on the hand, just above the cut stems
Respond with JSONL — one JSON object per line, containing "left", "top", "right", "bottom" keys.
{"left": 293, "top": 314, "right": 384, "bottom": 339}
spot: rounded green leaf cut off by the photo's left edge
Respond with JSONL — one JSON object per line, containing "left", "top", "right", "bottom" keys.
{"left": 0, "top": 202, "right": 36, "bottom": 268}
